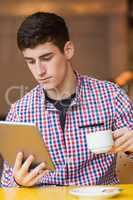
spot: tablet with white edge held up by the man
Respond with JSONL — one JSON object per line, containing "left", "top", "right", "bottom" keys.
{"left": 0, "top": 121, "right": 55, "bottom": 170}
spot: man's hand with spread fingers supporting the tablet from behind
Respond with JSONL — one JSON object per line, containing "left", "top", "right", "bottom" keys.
{"left": 13, "top": 152, "right": 49, "bottom": 187}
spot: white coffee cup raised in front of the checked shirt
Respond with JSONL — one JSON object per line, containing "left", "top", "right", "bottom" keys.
{"left": 87, "top": 130, "right": 114, "bottom": 153}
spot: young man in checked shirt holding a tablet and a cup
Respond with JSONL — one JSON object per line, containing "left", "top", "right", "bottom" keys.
{"left": 1, "top": 12, "right": 133, "bottom": 187}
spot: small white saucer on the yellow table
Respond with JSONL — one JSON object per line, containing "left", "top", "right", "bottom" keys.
{"left": 70, "top": 186, "right": 121, "bottom": 200}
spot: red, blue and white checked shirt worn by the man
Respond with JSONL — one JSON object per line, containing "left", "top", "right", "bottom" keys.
{"left": 1, "top": 73, "right": 133, "bottom": 187}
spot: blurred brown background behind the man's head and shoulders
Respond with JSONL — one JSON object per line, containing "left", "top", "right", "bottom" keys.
{"left": 0, "top": 0, "right": 133, "bottom": 119}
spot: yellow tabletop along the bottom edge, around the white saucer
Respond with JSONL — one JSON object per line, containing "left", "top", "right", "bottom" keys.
{"left": 0, "top": 184, "right": 133, "bottom": 200}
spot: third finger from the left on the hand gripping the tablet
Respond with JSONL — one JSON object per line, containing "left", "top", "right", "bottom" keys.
{"left": 26, "top": 163, "right": 46, "bottom": 182}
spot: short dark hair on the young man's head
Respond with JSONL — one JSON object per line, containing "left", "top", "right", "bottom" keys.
{"left": 17, "top": 12, "right": 69, "bottom": 52}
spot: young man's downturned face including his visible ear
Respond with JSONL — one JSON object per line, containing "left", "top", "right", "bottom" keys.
{"left": 22, "top": 41, "right": 73, "bottom": 90}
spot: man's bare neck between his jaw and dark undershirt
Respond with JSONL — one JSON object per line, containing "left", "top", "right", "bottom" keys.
{"left": 47, "top": 66, "right": 77, "bottom": 100}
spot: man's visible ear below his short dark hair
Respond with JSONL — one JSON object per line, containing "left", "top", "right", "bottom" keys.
{"left": 64, "top": 41, "right": 74, "bottom": 60}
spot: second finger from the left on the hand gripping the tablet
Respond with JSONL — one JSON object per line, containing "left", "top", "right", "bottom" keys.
{"left": 19, "top": 155, "right": 34, "bottom": 176}
